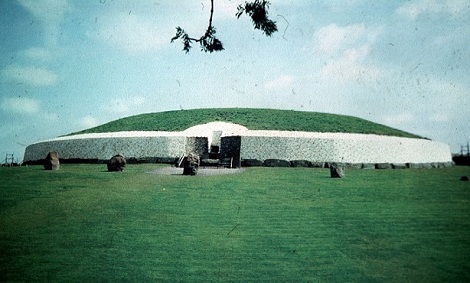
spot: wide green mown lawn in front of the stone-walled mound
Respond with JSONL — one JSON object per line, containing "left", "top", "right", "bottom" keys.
{"left": 0, "top": 164, "right": 470, "bottom": 282}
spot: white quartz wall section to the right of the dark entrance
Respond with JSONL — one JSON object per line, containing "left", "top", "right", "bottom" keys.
{"left": 240, "top": 135, "right": 452, "bottom": 163}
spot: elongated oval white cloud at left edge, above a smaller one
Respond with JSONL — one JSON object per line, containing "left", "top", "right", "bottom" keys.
{"left": 2, "top": 65, "right": 57, "bottom": 86}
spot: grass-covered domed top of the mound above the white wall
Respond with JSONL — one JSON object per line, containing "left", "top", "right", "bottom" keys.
{"left": 71, "top": 108, "right": 420, "bottom": 138}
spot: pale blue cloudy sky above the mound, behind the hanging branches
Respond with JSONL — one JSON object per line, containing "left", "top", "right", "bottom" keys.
{"left": 0, "top": 0, "right": 470, "bottom": 161}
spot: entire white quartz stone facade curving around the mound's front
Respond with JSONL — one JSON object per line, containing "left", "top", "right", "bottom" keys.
{"left": 24, "top": 122, "right": 452, "bottom": 168}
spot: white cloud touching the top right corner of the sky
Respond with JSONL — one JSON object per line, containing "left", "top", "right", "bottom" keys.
{"left": 396, "top": 0, "right": 470, "bottom": 20}
